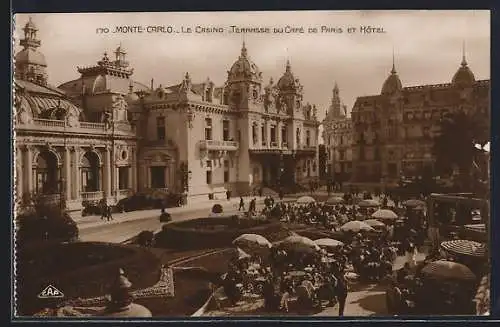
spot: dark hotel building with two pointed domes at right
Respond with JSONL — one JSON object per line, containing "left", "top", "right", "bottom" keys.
{"left": 352, "top": 51, "right": 490, "bottom": 186}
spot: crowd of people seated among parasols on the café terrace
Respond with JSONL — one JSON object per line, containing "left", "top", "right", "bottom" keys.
{"left": 224, "top": 193, "right": 436, "bottom": 315}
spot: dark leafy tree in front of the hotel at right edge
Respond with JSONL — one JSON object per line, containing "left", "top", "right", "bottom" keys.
{"left": 432, "top": 110, "right": 489, "bottom": 192}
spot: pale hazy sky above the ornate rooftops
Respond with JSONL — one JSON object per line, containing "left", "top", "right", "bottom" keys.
{"left": 14, "top": 10, "right": 490, "bottom": 129}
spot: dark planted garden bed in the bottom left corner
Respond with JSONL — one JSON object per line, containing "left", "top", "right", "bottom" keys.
{"left": 16, "top": 242, "right": 160, "bottom": 315}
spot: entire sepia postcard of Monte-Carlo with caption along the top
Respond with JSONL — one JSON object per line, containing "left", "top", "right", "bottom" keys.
{"left": 12, "top": 10, "right": 491, "bottom": 320}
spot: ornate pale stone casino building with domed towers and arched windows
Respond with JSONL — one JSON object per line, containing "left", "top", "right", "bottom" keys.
{"left": 14, "top": 19, "right": 319, "bottom": 210}
